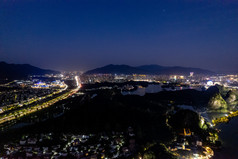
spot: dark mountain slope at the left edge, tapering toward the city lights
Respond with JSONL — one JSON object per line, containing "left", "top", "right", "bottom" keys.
{"left": 0, "top": 62, "right": 59, "bottom": 79}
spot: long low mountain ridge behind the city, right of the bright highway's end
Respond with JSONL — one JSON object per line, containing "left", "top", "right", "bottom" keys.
{"left": 85, "top": 64, "right": 214, "bottom": 75}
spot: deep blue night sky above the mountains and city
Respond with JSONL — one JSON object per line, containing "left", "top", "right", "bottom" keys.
{"left": 0, "top": 0, "right": 238, "bottom": 72}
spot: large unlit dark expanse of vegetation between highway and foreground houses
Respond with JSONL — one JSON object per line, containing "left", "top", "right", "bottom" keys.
{"left": 0, "top": 83, "right": 225, "bottom": 158}
